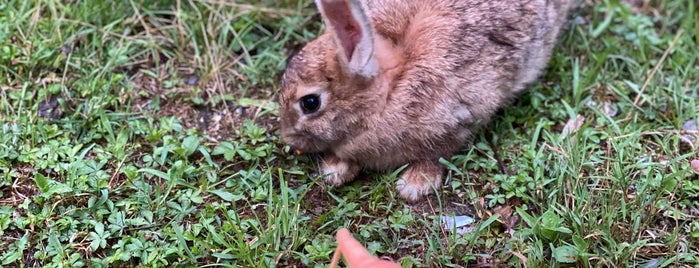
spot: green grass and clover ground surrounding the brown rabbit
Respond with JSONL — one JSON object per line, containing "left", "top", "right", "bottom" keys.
{"left": 0, "top": 0, "right": 699, "bottom": 267}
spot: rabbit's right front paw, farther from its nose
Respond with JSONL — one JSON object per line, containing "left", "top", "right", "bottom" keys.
{"left": 396, "top": 161, "right": 443, "bottom": 202}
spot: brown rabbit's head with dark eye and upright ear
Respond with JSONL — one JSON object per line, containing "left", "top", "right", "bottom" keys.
{"left": 279, "top": 0, "right": 383, "bottom": 152}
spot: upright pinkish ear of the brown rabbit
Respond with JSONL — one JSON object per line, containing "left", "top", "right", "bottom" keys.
{"left": 316, "top": 0, "right": 379, "bottom": 78}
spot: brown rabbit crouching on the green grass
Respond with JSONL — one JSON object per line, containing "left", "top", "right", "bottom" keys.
{"left": 279, "top": 0, "right": 575, "bottom": 201}
